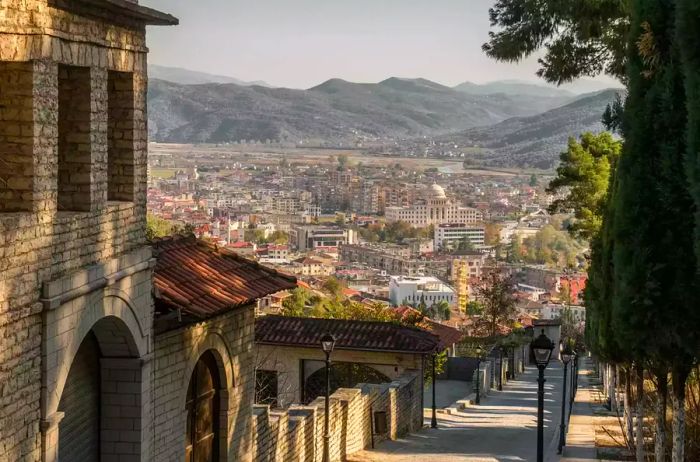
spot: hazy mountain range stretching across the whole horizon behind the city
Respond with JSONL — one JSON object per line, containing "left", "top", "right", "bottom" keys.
{"left": 148, "top": 66, "right": 612, "bottom": 170}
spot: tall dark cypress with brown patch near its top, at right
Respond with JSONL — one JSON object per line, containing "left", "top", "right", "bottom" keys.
{"left": 612, "top": 0, "right": 696, "bottom": 461}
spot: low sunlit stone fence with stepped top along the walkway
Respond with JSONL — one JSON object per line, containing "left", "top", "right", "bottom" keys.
{"left": 253, "top": 373, "right": 423, "bottom": 462}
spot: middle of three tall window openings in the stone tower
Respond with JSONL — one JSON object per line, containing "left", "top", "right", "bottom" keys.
{"left": 58, "top": 65, "right": 92, "bottom": 211}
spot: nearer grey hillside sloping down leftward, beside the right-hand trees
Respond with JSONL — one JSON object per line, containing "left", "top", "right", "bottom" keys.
{"left": 439, "top": 90, "right": 620, "bottom": 168}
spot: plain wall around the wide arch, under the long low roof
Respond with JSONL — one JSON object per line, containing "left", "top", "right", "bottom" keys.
{"left": 254, "top": 344, "right": 422, "bottom": 408}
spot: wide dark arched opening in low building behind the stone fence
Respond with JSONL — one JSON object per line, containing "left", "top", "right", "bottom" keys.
{"left": 303, "top": 362, "right": 391, "bottom": 404}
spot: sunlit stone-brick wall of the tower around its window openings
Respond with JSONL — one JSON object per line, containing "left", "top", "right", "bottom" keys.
{"left": 0, "top": 0, "right": 151, "bottom": 461}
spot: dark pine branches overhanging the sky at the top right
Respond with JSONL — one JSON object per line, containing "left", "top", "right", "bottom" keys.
{"left": 483, "top": 0, "right": 630, "bottom": 84}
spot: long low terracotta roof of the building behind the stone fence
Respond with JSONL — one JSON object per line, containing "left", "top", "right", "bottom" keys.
{"left": 255, "top": 316, "right": 439, "bottom": 353}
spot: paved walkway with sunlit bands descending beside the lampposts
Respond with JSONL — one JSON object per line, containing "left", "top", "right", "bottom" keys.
{"left": 349, "top": 363, "right": 562, "bottom": 462}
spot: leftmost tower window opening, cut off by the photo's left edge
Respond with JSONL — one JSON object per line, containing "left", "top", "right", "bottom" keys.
{"left": 0, "top": 62, "right": 34, "bottom": 213}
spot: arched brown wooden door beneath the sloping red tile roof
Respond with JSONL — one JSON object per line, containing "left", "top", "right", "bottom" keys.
{"left": 185, "top": 351, "right": 221, "bottom": 462}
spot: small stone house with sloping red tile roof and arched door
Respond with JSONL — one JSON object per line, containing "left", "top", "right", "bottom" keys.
{"left": 153, "top": 237, "right": 296, "bottom": 460}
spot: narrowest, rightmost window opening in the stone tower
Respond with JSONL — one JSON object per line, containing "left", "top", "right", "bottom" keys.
{"left": 107, "top": 71, "right": 136, "bottom": 201}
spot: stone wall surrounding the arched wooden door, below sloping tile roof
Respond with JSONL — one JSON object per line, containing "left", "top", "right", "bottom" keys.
{"left": 153, "top": 305, "right": 255, "bottom": 462}
